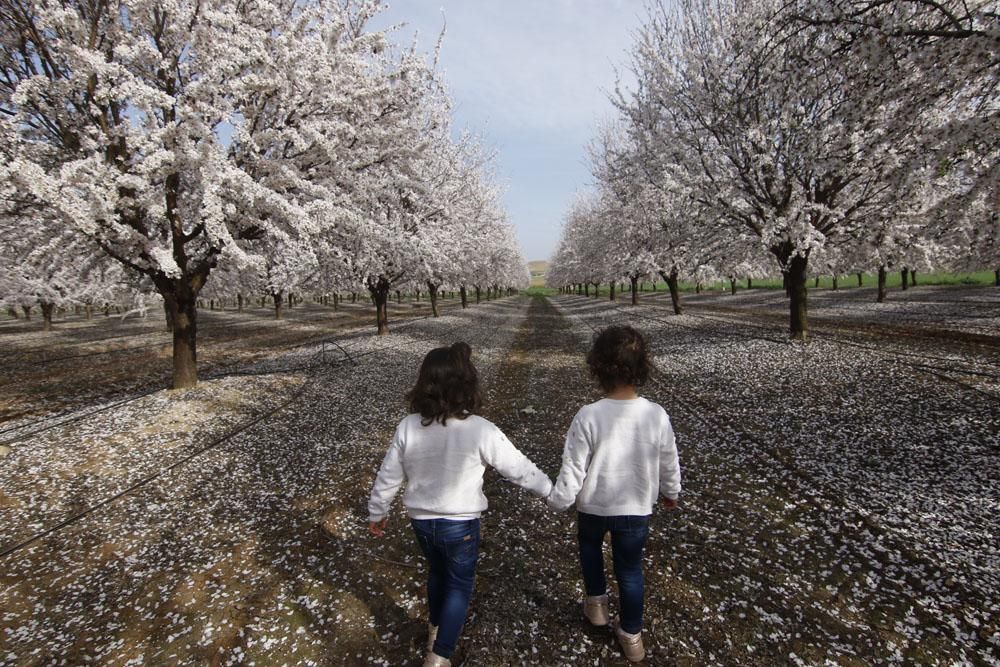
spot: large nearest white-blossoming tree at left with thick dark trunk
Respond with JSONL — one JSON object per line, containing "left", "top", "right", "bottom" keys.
{"left": 0, "top": 0, "right": 444, "bottom": 387}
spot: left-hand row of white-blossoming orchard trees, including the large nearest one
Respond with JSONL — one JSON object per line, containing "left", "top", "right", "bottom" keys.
{"left": 0, "top": 0, "right": 529, "bottom": 387}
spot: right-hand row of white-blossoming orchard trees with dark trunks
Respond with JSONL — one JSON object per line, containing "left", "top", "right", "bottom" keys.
{"left": 547, "top": 0, "right": 1000, "bottom": 338}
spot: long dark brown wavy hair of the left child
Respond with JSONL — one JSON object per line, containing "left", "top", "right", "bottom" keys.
{"left": 406, "top": 342, "right": 482, "bottom": 426}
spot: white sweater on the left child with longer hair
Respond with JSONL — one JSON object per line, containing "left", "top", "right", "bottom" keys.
{"left": 368, "top": 414, "right": 552, "bottom": 521}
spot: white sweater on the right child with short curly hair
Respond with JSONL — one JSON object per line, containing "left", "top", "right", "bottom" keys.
{"left": 548, "top": 398, "right": 681, "bottom": 516}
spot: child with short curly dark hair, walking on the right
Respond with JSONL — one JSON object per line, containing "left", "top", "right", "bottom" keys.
{"left": 548, "top": 326, "right": 681, "bottom": 662}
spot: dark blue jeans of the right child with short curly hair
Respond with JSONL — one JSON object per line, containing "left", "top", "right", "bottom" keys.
{"left": 577, "top": 512, "right": 649, "bottom": 634}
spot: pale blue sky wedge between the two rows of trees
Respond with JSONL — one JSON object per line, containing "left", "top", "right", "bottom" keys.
{"left": 372, "top": 0, "right": 645, "bottom": 260}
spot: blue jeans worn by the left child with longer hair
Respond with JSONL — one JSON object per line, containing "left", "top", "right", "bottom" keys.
{"left": 410, "top": 519, "right": 479, "bottom": 658}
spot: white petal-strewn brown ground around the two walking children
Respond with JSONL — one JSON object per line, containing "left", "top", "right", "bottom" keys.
{"left": 0, "top": 288, "right": 1000, "bottom": 665}
